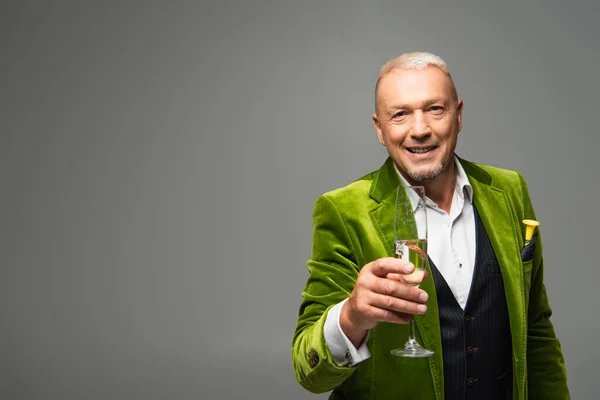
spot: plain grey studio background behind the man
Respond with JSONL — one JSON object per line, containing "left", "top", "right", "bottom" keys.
{"left": 0, "top": 0, "right": 600, "bottom": 399}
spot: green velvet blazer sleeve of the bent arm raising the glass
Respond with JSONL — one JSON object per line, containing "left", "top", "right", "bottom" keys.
{"left": 292, "top": 195, "right": 359, "bottom": 393}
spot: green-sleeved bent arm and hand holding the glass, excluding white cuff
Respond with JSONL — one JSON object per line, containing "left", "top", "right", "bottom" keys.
{"left": 292, "top": 196, "right": 428, "bottom": 393}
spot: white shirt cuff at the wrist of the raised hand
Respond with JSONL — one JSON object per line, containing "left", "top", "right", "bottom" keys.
{"left": 323, "top": 299, "right": 371, "bottom": 367}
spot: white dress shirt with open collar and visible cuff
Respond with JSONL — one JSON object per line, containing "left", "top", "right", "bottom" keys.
{"left": 323, "top": 157, "right": 476, "bottom": 367}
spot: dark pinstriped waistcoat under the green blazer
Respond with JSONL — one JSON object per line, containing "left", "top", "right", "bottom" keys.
{"left": 430, "top": 206, "right": 512, "bottom": 400}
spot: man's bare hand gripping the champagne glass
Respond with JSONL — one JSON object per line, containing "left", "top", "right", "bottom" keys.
{"left": 340, "top": 258, "right": 429, "bottom": 347}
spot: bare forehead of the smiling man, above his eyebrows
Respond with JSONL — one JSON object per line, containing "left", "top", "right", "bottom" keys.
{"left": 377, "top": 66, "right": 454, "bottom": 106}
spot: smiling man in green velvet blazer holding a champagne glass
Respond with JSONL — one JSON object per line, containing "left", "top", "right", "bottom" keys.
{"left": 292, "top": 53, "right": 569, "bottom": 400}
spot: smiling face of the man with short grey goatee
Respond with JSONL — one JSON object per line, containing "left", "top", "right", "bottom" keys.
{"left": 373, "top": 66, "right": 463, "bottom": 184}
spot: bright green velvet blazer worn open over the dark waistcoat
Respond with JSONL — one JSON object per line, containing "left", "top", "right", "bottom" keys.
{"left": 292, "top": 158, "right": 570, "bottom": 400}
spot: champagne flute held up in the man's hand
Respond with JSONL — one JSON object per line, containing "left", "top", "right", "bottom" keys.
{"left": 391, "top": 186, "right": 433, "bottom": 358}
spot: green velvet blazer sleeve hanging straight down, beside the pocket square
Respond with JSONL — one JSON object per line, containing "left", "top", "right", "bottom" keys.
{"left": 519, "top": 174, "right": 571, "bottom": 400}
